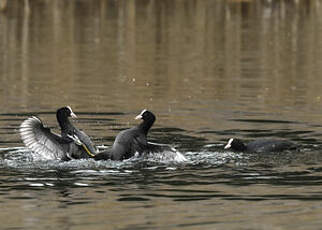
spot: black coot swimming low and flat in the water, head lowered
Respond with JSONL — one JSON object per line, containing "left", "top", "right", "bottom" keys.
{"left": 224, "top": 138, "right": 298, "bottom": 153}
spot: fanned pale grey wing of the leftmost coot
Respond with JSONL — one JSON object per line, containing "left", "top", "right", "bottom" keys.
{"left": 19, "top": 116, "right": 67, "bottom": 159}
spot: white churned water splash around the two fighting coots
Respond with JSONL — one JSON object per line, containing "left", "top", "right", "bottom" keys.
{"left": 0, "top": 146, "right": 241, "bottom": 173}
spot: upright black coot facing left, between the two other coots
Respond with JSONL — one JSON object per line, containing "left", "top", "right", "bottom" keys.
{"left": 94, "top": 109, "right": 156, "bottom": 160}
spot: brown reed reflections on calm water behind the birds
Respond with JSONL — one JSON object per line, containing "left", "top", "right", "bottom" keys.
{"left": 0, "top": 0, "right": 322, "bottom": 114}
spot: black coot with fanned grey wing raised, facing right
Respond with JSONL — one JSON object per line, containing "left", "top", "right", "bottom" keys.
{"left": 19, "top": 106, "right": 96, "bottom": 160}
